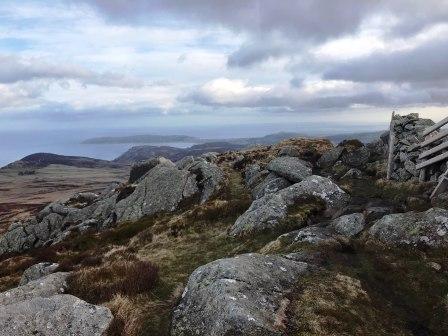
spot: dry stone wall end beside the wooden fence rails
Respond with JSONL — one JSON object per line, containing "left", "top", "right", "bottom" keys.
{"left": 391, "top": 113, "right": 446, "bottom": 181}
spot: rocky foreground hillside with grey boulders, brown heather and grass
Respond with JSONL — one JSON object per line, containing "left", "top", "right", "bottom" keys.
{"left": 0, "top": 130, "right": 448, "bottom": 336}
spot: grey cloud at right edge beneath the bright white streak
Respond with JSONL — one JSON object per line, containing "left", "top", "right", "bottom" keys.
{"left": 323, "top": 38, "right": 448, "bottom": 83}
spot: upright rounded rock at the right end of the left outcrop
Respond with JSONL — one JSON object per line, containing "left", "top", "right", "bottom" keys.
{"left": 189, "top": 162, "right": 224, "bottom": 204}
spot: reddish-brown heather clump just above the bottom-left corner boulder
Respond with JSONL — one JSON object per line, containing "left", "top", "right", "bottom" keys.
{"left": 68, "top": 260, "right": 158, "bottom": 304}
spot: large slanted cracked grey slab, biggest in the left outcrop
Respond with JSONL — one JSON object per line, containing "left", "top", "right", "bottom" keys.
{"left": 115, "top": 164, "right": 199, "bottom": 222}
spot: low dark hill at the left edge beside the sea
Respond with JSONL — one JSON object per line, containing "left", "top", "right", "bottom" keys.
{"left": 2, "top": 153, "right": 120, "bottom": 169}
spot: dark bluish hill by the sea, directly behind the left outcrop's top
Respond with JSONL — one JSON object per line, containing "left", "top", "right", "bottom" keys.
{"left": 114, "top": 142, "right": 243, "bottom": 164}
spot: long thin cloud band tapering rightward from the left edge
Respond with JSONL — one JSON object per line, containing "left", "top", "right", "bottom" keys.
{"left": 0, "top": 55, "right": 144, "bottom": 88}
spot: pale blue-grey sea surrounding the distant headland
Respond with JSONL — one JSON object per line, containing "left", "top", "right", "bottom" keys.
{"left": 0, "top": 123, "right": 384, "bottom": 167}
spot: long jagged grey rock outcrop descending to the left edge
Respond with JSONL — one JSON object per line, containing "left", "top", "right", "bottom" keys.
{"left": 0, "top": 158, "right": 224, "bottom": 255}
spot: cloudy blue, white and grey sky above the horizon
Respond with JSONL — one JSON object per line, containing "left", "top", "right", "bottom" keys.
{"left": 0, "top": 0, "right": 448, "bottom": 130}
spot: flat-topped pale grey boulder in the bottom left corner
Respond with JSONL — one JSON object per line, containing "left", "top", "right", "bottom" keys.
{"left": 0, "top": 295, "right": 113, "bottom": 336}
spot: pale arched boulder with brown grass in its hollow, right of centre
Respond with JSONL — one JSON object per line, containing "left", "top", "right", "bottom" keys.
{"left": 230, "top": 175, "right": 349, "bottom": 236}
